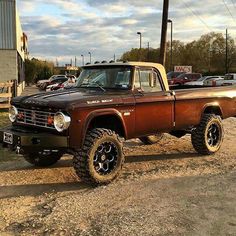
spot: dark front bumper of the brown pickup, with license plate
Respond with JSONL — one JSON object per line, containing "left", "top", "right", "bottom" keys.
{"left": 0, "top": 126, "right": 69, "bottom": 152}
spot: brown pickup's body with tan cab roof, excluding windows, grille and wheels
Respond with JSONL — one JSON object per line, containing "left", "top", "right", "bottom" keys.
{"left": 0, "top": 62, "right": 236, "bottom": 152}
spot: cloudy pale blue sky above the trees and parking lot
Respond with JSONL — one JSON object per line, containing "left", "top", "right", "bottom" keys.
{"left": 18, "top": 0, "right": 236, "bottom": 65}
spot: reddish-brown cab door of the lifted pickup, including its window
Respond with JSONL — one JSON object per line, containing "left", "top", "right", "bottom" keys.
{"left": 134, "top": 68, "right": 175, "bottom": 136}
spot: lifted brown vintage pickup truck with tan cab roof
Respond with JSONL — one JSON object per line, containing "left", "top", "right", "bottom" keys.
{"left": 0, "top": 62, "right": 236, "bottom": 184}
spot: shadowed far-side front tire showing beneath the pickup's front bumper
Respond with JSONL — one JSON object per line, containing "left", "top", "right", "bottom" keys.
{"left": 23, "top": 153, "right": 62, "bottom": 167}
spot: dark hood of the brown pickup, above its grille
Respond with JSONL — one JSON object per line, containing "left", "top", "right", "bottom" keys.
{"left": 12, "top": 88, "right": 131, "bottom": 110}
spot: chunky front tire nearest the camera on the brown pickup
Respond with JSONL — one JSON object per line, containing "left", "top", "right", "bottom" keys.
{"left": 73, "top": 128, "right": 124, "bottom": 185}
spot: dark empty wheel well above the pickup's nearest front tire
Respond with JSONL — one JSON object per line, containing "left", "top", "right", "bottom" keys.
{"left": 88, "top": 115, "right": 126, "bottom": 138}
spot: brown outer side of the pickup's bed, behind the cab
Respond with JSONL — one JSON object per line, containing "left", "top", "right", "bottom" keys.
{"left": 173, "top": 86, "right": 236, "bottom": 129}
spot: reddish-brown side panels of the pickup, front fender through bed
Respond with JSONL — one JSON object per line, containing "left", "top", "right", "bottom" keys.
{"left": 70, "top": 84, "right": 236, "bottom": 146}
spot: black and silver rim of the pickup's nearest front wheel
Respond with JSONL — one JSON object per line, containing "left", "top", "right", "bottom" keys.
{"left": 93, "top": 142, "right": 119, "bottom": 175}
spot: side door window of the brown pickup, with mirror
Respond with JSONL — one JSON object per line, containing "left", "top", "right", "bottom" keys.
{"left": 135, "top": 69, "right": 162, "bottom": 92}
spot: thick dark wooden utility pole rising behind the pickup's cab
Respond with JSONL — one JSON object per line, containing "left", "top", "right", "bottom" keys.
{"left": 159, "top": 0, "right": 169, "bottom": 66}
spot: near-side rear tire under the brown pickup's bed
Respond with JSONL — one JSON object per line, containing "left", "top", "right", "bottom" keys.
{"left": 191, "top": 114, "right": 224, "bottom": 155}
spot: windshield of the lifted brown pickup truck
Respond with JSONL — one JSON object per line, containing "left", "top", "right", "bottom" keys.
{"left": 76, "top": 66, "right": 131, "bottom": 89}
